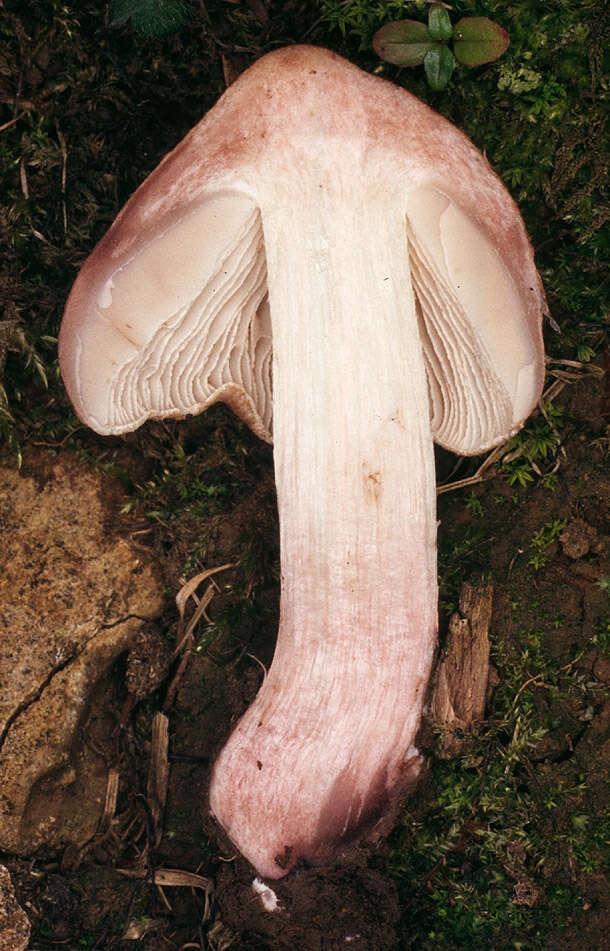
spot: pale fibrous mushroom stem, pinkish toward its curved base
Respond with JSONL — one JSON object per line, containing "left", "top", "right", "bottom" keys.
{"left": 210, "top": 186, "right": 437, "bottom": 878}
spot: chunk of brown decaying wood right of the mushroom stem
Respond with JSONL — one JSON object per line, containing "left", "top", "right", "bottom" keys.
{"left": 430, "top": 582, "right": 493, "bottom": 759}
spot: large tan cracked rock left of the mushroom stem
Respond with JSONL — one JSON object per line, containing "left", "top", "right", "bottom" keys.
{"left": 0, "top": 453, "right": 162, "bottom": 854}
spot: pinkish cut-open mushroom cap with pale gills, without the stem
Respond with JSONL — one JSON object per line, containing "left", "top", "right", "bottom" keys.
{"left": 59, "top": 46, "right": 544, "bottom": 454}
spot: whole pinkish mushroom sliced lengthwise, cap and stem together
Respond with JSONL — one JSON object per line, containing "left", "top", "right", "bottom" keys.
{"left": 59, "top": 46, "right": 544, "bottom": 878}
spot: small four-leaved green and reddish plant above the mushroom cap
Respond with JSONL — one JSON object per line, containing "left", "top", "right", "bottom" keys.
{"left": 373, "top": 3, "right": 510, "bottom": 90}
